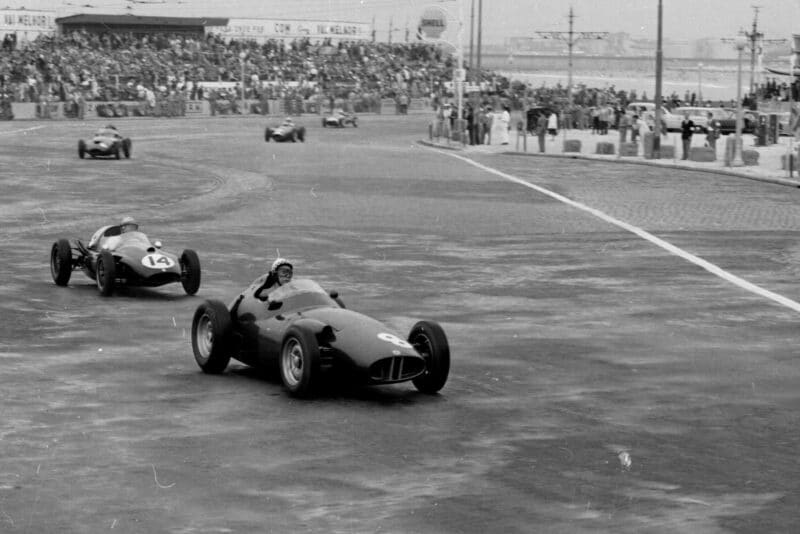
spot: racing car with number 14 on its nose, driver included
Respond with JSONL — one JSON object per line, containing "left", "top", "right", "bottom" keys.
{"left": 50, "top": 225, "right": 200, "bottom": 296}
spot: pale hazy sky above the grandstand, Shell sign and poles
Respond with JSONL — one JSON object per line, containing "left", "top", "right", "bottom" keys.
{"left": 6, "top": 0, "right": 800, "bottom": 44}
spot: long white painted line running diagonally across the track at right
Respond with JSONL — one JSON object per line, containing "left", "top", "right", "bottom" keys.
{"left": 437, "top": 150, "right": 800, "bottom": 312}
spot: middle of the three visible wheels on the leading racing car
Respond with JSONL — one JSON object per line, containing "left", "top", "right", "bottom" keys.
{"left": 280, "top": 326, "right": 320, "bottom": 397}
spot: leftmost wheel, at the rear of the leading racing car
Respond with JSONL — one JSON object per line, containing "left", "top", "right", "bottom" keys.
{"left": 192, "top": 300, "right": 231, "bottom": 375}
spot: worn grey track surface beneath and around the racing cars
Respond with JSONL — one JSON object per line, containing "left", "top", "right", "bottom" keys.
{"left": 0, "top": 116, "right": 800, "bottom": 534}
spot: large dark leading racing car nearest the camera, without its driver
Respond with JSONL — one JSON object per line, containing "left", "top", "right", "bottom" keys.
{"left": 192, "top": 277, "right": 450, "bottom": 397}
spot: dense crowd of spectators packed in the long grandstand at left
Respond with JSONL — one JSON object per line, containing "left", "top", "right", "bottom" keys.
{"left": 0, "top": 31, "right": 454, "bottom": 114}
